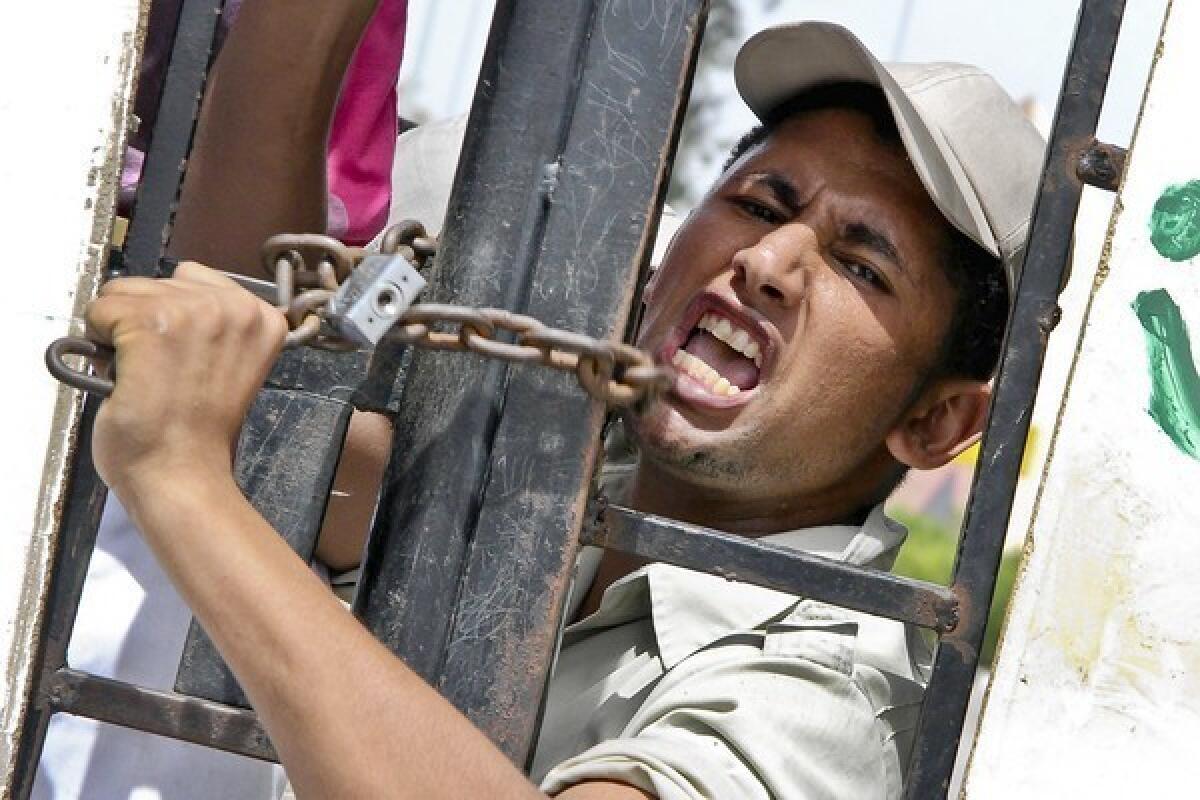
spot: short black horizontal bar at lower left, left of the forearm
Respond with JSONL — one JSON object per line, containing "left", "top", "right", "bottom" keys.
{"left": 44, "top": 668, "right": 278, "bottom": 762}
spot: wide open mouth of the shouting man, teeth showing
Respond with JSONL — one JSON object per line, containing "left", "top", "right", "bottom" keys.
{"left": 671, "top": 308, "right": 763, "bottom": 398}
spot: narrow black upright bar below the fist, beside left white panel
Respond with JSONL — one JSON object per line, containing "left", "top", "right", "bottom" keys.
{"left": 13, "top": 397, "right": 107, "bottom": 800}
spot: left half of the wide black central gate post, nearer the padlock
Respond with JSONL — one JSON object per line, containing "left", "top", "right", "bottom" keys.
{"left": 355, "top": 0, "right": 609, "bottom": 682}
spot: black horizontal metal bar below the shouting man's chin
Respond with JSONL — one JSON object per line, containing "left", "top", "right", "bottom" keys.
{"left": 582, "top": 506, "right": 959, "bottom": 633}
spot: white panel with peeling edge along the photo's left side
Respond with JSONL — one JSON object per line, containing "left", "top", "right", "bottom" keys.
{"left": 0, "top": 0, "right": 140, "bottom": 796}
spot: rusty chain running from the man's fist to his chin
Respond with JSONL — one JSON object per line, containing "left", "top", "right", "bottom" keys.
{"left": 263, "top": 221, "right": 674, "bottom": 405}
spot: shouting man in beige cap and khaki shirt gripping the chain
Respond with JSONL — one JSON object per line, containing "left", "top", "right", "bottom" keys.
{"left": 88, "top": 23, "right": 1042, "bottom": 800}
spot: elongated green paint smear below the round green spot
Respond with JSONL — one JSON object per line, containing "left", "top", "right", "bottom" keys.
{"left": 1133, "top": 289, "right": 1200, "bottom": 461}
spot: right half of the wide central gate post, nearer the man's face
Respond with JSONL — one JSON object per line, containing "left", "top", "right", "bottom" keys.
{"left": 439, "top": 0, "right": 706, "bottom": 763}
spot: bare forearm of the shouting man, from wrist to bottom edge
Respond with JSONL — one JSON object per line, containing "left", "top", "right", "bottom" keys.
{"left": 115, "top": 475, "right": 542, "bottom": 799}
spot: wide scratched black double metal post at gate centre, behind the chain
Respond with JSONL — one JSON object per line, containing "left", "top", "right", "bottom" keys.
{"left": 359, "top": 0, "right": 704, "bottom": 763}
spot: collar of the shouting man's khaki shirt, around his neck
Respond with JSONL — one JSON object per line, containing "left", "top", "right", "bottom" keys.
{"left": 564, "top": 506, "right": 905, "bottom": 669}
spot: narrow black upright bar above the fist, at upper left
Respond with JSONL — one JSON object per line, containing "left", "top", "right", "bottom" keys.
{"left": 124, "top": 0, "right": 224, "bottom": 276}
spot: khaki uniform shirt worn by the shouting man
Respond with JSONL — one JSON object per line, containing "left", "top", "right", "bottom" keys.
{"left": 532, "top": 509, "right": 931, "bottom": 800}
